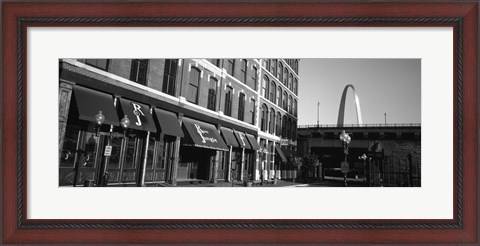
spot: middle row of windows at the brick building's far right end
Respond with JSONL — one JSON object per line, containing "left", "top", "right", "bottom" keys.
{"left": 261, "top": 75, "right": 297, "bottom": 117}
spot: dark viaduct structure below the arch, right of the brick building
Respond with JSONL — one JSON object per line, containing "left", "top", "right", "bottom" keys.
{"left": 298, "top": 124, "right": 421, "bottom": 187}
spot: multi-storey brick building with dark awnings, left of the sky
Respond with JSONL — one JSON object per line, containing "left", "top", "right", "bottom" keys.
{"left": 59, "top": 59, "right": 299, "bottom": 186}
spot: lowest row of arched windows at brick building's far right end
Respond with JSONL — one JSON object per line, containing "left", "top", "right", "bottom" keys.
{"left": 260, "top": 104, "right": 297, "bottom": 140}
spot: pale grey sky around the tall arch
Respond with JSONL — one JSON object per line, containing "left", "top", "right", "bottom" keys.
{"left": 298, "top": 59, "right": 421, "bottom": 125}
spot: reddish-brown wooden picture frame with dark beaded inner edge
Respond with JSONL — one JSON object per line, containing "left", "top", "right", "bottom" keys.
{"left": 1, "top": 1, "right": 479, "bottom": 244}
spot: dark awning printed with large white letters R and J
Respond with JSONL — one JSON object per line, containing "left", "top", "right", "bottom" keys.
{"left": 120, "top": 98, "right": 157, "bottom": 132}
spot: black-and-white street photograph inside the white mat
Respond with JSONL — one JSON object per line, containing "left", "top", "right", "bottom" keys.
{"left": 58, "top": 58, "right": 421, "bottom": 188}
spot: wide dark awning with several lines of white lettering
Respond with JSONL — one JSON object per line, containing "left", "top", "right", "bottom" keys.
{"left": 183, "top": 117, "right": 228, "bottom": 151}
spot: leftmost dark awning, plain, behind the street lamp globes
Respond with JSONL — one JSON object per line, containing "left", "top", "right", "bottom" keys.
{"left": 73, "top": 86, "right": 119, "bottom": 126}
